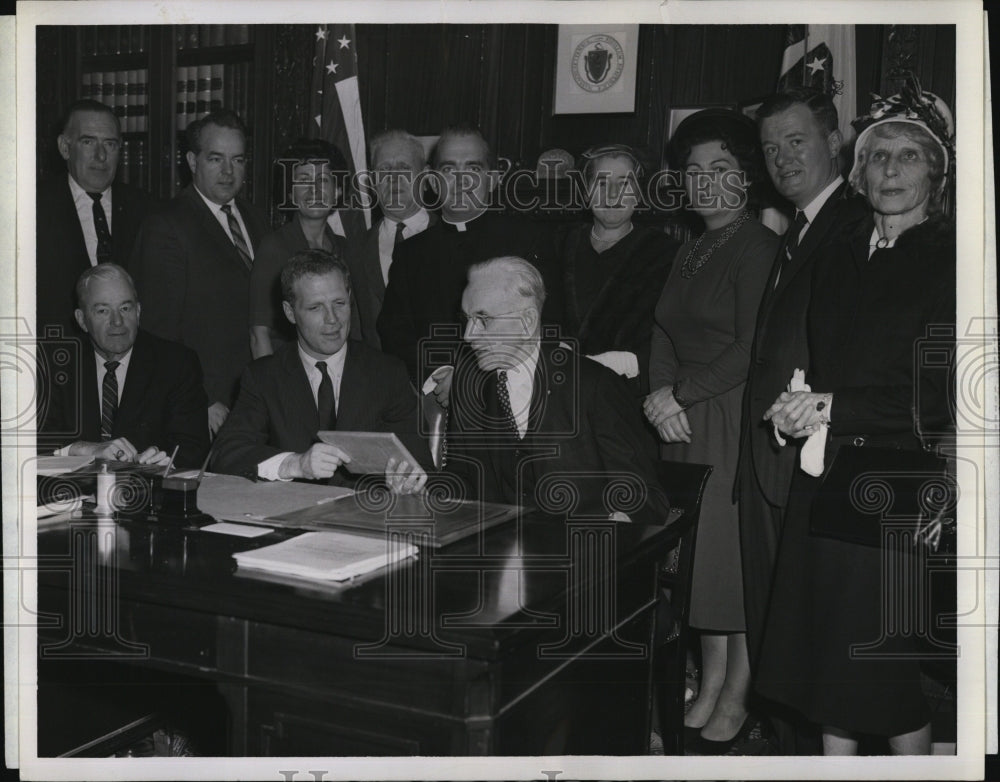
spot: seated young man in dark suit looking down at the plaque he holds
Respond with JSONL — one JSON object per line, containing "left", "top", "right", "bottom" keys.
{"left": 212, "top": 250, "right": 430, "bottom": 493}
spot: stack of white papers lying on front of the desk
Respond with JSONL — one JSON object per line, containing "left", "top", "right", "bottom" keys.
{"left": 233, "top": 532, "right": 417, "bottom": 581}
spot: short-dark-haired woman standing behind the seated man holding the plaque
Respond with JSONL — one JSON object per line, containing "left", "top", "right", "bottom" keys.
{"left": 250, "top": 139, "right": 361, "bottom": 358}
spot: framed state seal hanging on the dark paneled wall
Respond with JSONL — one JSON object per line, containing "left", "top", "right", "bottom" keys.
{"left": 552, "top": 24, "right": 639, "bottom": 114}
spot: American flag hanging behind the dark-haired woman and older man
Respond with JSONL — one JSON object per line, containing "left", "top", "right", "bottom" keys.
{"left": 310, "top": 24, "right": 371, "bottom": 231}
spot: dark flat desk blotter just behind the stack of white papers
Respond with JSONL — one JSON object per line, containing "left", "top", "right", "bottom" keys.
{"left": 272, "top": 490, "right": 519, "bottom": 548}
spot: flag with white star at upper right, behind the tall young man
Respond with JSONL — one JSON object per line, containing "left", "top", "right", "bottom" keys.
{"left": 778, "top": 24, "right": 858, "bottom": 142}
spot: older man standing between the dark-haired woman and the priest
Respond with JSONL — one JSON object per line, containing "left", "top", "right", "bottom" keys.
{"left": 348, "top": 130, "right": 437, "bottom": 350}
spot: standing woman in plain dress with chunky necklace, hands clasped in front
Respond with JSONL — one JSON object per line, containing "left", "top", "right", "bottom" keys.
{"left": 644, "top": 109, "right": 779, "bottom": 754}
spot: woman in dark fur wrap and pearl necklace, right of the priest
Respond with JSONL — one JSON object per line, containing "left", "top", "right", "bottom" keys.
{"left": 561, "top": 144, "right": 677, "bottom": 395}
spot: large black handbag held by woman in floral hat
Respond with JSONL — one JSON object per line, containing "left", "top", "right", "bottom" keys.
{"left": 809, "top": 445, "right": 958, "bottom": 554}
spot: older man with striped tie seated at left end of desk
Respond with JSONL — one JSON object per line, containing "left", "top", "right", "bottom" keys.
{"left": 39, "top": 263, "right": 208, "bottom": 467}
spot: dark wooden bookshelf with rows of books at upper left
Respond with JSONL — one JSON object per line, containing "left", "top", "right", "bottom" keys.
{"left": 69, "top": 24, "right": 273, "bottom": 204}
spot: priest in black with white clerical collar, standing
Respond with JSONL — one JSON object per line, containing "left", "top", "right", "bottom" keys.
{"left": 378, "top": 126, "right": 558, "bottom": 403}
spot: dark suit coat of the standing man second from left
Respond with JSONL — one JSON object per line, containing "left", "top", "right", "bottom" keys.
{"left": 131, "top": 185, "right": 267, "bottom": 406}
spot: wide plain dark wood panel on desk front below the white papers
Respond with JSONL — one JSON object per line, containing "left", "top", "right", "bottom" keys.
{"left": 244, "top": 623, "right": 489, "bottom": 717}
